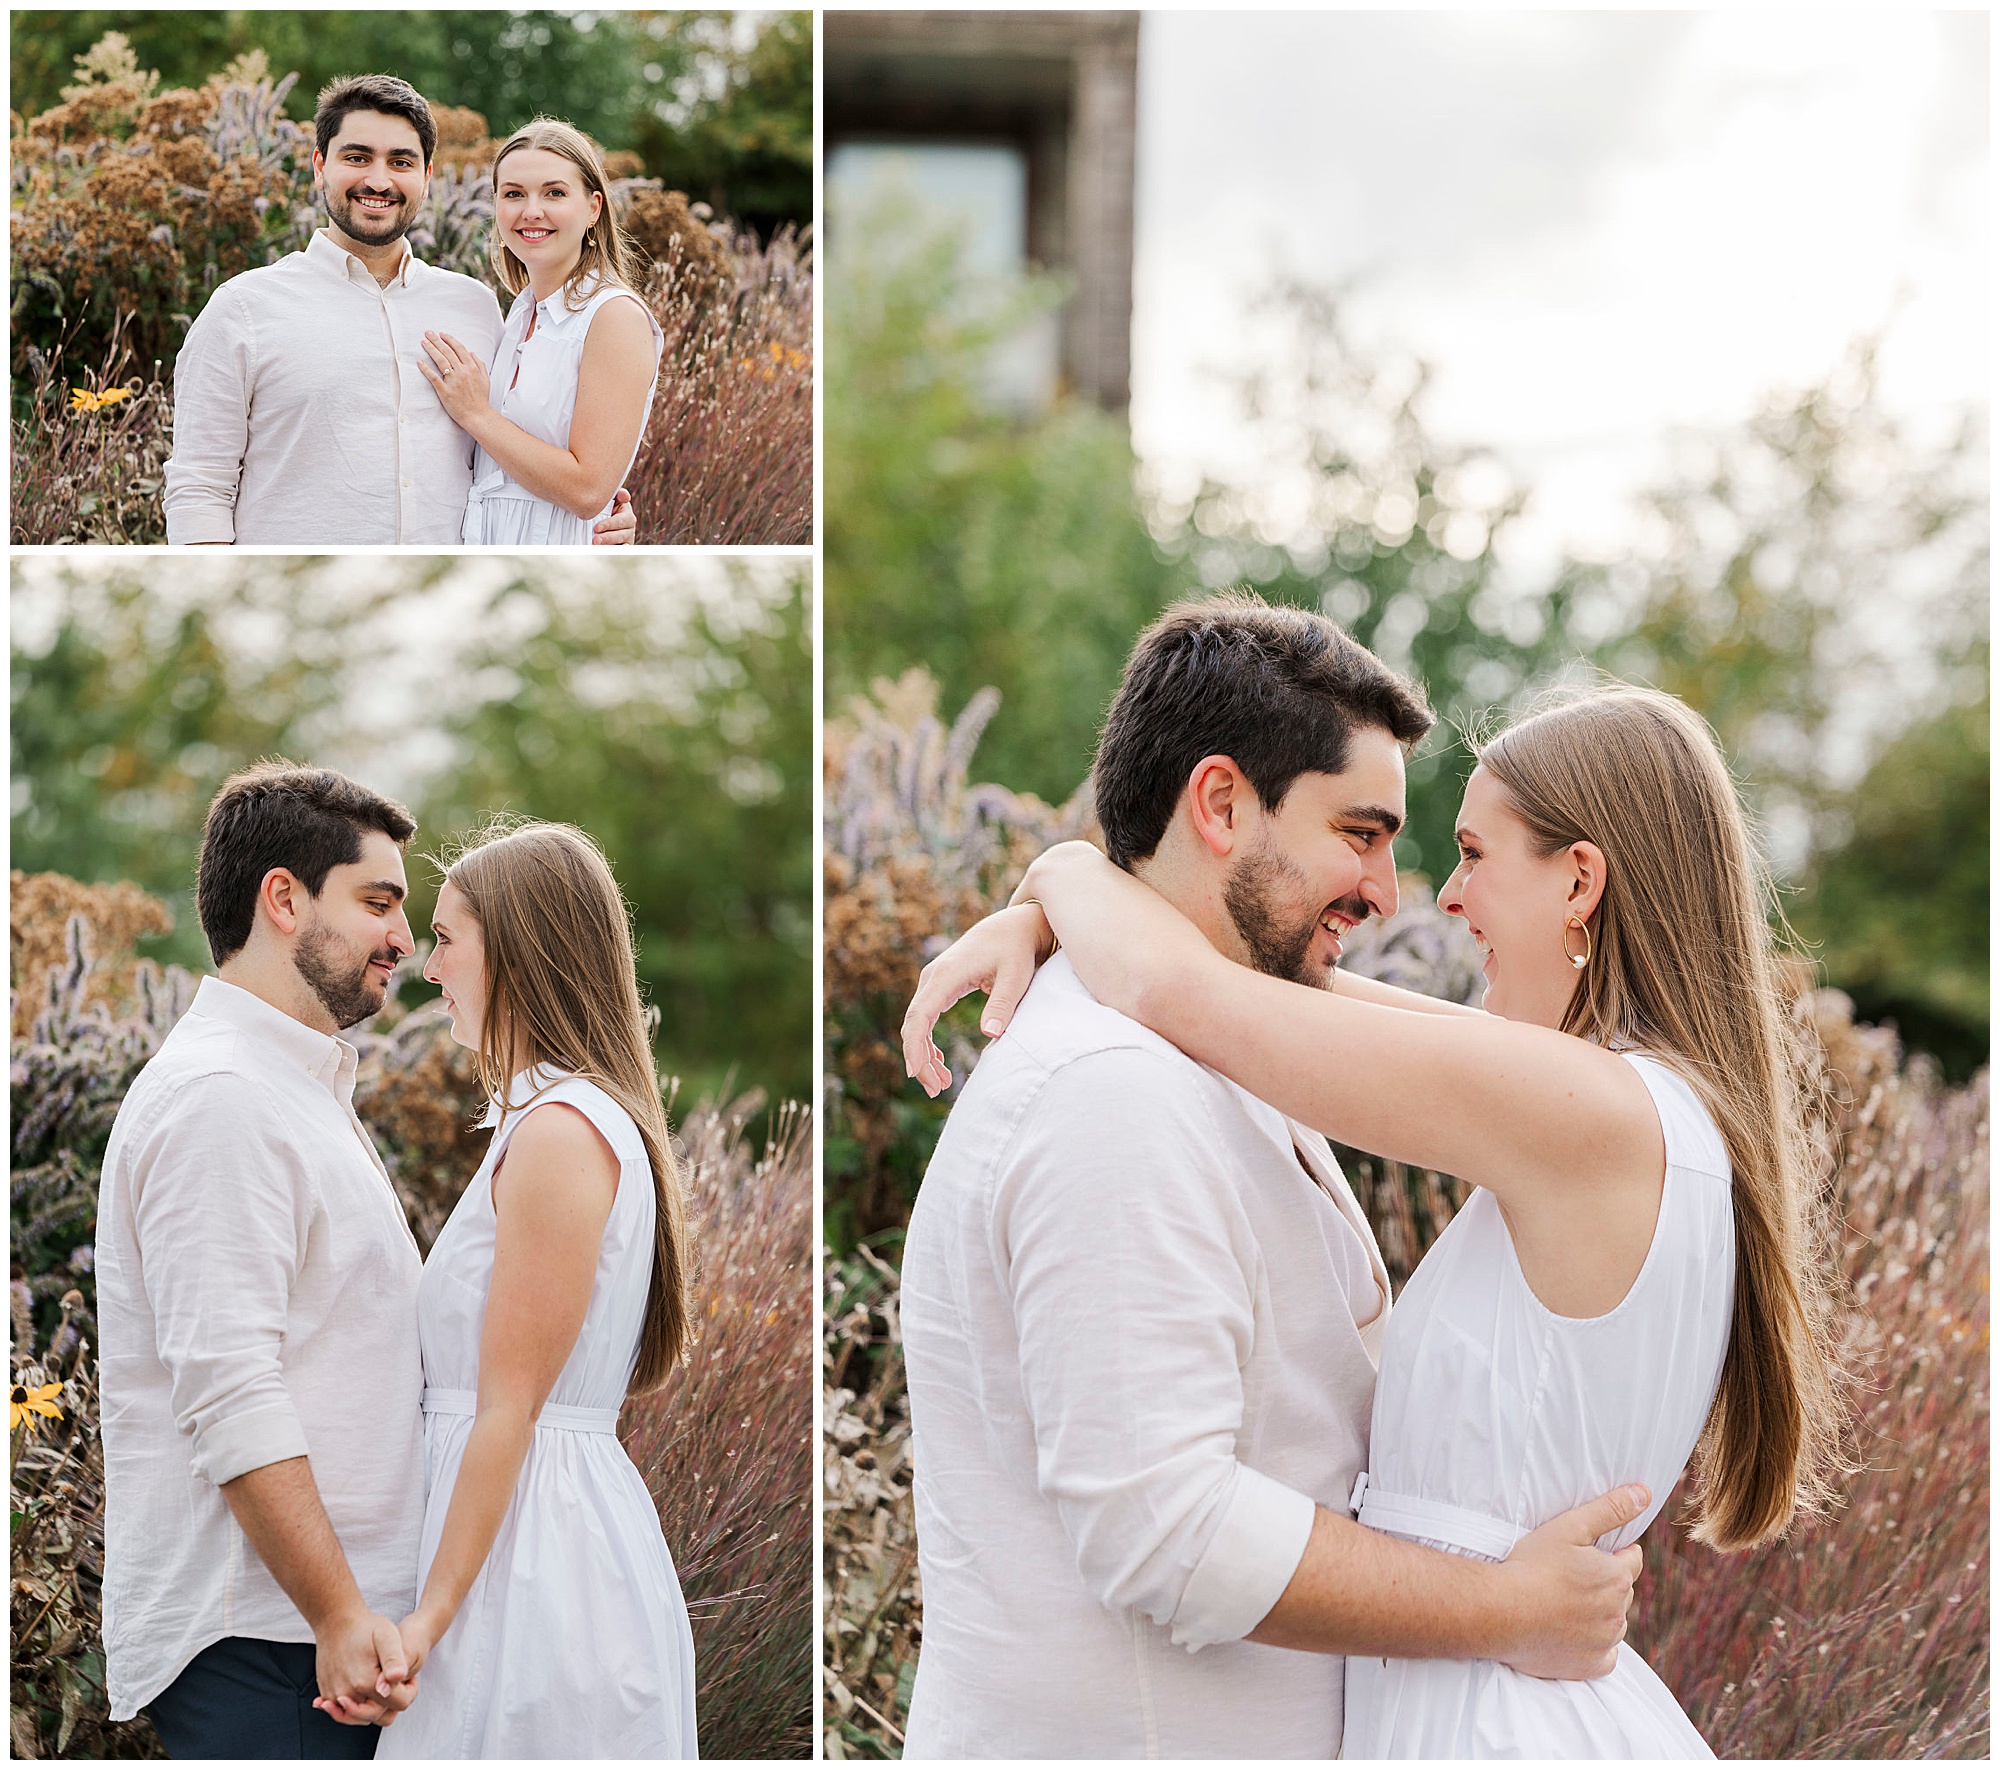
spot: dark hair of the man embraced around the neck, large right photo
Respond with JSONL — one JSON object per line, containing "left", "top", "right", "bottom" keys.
{"left": 1092, "top": 590, "right": 1436, "bottom": 866}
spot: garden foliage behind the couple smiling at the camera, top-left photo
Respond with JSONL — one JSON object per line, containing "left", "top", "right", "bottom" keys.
{"left": 10, "top": 12, "right": 812, "bottom": 544}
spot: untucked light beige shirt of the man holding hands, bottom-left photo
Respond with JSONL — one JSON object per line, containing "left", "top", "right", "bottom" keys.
{"left": 96, "top": 978, "right": 424, "bottom": 1720}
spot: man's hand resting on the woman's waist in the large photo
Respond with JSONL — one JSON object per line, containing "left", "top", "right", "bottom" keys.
{"left": 1494, "top": 1486, "right": 1652, "bottom": 1678}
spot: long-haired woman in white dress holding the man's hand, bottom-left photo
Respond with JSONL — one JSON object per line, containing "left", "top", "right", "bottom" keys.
{"left": 352, "top": 824, "right": 696, "bottom": 1758}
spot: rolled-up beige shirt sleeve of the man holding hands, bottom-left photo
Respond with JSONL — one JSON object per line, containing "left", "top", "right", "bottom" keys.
{"left": 132, "top": 1074, "right": 314, "bottom": 1486}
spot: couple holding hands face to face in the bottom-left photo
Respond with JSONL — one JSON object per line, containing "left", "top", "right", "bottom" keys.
{"left": 96, "top": 762, "right": 696, "bottom": 1758}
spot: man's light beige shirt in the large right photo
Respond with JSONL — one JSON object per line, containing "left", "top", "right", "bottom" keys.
{"left": 902, "top": 954, "right": 1388, "bottom": 1758}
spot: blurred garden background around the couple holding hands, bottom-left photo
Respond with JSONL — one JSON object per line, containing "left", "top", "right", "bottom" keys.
{"left": 10, "top": 556, "right": 812, "bottom": 1756}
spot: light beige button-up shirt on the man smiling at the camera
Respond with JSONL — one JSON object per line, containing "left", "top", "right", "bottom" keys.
{"left": 166, "top": 232, "right": 502, "bottom": 546}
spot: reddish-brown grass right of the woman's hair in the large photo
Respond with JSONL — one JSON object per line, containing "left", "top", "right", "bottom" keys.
{"left": 1632, "top": 990, "right": 1992, "bottom": 1758}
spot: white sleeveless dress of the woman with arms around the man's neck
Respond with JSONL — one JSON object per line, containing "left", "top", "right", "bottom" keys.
{"left": 1340, "top": 1052, "right": 1736, "bottom": 1758}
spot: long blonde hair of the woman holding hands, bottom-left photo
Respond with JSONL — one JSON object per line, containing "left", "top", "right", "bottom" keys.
{"left": 444, "top": 824, "right": 690, "bottom": 1394}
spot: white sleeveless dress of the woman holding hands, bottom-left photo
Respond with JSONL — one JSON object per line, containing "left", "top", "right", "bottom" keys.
{"left": 376, "top": 1068, "right": 698, "bottom": 1758}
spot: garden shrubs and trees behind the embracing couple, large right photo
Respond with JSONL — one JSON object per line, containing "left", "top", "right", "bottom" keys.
{"left": 822, "top": 192, "right": 1990, "bottom": 1756}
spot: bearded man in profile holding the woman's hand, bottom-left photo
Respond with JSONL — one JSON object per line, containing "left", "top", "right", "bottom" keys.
{"left": 96, "top": 762, "right": 424, "bottom": 1758}
